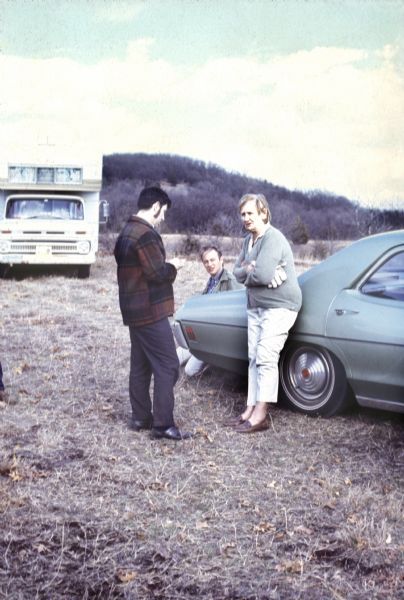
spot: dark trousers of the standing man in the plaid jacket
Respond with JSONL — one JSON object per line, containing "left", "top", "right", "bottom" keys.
{"left": 129, "top": 318, "right": 179, "bottom": 427}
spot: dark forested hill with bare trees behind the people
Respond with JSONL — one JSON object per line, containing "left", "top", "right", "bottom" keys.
{"left": 102, "top": 154, "right": 404, "bottom": 243}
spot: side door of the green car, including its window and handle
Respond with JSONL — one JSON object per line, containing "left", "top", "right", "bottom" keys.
{"left": 326, "top": 247, "right": 404, "bottom": 408}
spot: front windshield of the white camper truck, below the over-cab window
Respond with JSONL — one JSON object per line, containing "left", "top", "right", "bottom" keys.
{"left": 6, "top": 196, "right": 84, "bottom": 220}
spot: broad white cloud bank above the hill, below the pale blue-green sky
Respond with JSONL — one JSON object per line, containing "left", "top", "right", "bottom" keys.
{"left": 0, "top": 39, "right": 404, "bottom": 205}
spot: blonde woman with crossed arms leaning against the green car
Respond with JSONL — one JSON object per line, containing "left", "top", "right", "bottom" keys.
{"left": 226, "top": 194, "right": 302, "bottom": 433}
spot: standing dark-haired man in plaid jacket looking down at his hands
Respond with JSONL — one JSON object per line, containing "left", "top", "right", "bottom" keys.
{"left": 114, "top": 187, "right": 190, "bottom": 440}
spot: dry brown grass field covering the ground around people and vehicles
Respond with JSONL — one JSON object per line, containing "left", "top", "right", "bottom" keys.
{"left": 0, "top": 240, "right": 404, "bottom": 600}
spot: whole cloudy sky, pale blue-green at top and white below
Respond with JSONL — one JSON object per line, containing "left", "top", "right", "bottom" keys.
{"left": 0, "top": 0, "right": 404, "bottom": 207}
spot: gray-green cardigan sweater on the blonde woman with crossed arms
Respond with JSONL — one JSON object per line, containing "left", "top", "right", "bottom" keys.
{"left": 233, "top": 225, "right": 302, "bottom": 311}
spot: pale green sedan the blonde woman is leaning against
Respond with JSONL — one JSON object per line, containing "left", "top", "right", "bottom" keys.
{"left": 174, "top": 230, "right": 404, "bottom": 417}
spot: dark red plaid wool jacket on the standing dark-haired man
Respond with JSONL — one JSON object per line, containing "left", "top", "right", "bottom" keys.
{"left": 114, "top": 216, "right": 177, "bottom": 326}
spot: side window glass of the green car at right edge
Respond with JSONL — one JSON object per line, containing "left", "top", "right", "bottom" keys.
{"left": 361, "top": 252, "right": 404, "bottom": 302}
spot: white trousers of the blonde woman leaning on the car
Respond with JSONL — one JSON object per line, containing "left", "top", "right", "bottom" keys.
{"left": 247, "top": 308, "right": 297, "bottom": 406}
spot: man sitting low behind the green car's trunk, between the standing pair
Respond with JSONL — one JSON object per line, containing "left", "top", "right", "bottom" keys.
{"left": 177, "top": 246, "right": 243, "bottom": 377}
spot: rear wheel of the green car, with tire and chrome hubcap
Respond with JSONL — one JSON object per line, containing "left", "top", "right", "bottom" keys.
{"left": 279, "top": 345, "right": 349, "bottom": 417}
